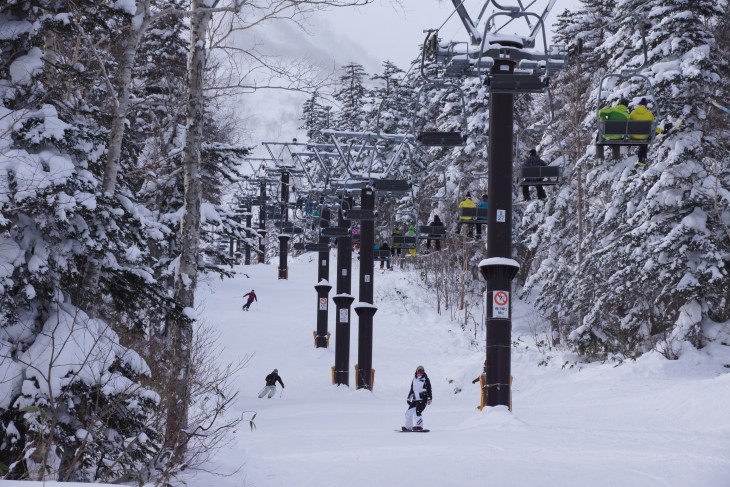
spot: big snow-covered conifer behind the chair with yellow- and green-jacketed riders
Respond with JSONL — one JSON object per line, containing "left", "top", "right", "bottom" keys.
{"left": 523, "top": 0, "right": 730, "bottom": 357}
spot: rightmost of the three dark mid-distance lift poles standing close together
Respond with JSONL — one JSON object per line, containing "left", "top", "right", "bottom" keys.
{"left": 355, "top": 187, "right": 378, "bottom": 390}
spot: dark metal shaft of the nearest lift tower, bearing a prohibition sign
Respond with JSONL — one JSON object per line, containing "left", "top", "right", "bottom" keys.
{"left": 480, "top": 60, "right": 519, "bottom": 407}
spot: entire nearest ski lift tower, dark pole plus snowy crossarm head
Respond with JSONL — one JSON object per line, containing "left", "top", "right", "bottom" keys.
{"left": 424, "top": 0, "right": 566, "bottom": 409}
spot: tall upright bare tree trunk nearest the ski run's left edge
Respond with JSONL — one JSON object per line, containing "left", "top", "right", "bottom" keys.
{"left": 165, "top": 0, "right": 212, "bottom": 462}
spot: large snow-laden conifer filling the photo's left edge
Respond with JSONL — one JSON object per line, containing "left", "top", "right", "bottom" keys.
{"left": 0, "top": 1, "right": 166, "bottom": 480}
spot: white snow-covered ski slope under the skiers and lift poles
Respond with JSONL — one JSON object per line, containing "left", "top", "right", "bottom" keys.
{"left": 5, "top": 253, "right": 730, "bottom": 487}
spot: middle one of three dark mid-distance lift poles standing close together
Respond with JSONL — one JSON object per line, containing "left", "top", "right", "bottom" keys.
{"left": 332, "top": 198, "right": 355, "bottom": 386}
